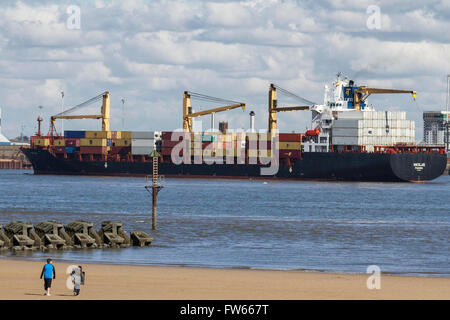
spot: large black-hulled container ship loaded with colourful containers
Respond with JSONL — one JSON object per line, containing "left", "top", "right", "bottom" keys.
{"left": 23, "top": 75, "right": 447, "bottom": 182}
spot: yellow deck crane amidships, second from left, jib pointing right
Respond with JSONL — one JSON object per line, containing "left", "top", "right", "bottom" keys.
{"left": 183, "top": 91, "right": 245, "bottom": 132}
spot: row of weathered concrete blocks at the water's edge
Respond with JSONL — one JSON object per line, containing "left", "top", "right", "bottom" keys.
{"left": 0, "top": 220, "right": 153, "bottom": 251}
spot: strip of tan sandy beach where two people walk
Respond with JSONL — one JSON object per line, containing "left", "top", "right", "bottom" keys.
{"left": 0, "top": 259, "right": 450, "bottom": 300}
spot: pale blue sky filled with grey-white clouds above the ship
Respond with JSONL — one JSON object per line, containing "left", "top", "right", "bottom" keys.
{"left": 0, "top": 0, "right": 450, "bottom": 139}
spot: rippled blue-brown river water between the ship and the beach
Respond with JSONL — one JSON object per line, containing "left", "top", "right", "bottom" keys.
{"left": 0, "top": 170, "right": 450, "bottom": 277}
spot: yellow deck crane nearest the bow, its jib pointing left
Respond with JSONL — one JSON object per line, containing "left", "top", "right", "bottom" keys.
{"left": 49, "top": 91, "right": 110, "bottom": 136}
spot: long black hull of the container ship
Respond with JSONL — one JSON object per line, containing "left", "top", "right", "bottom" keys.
{"left": 23, "top": 149, "right": 447, "bottom": 182}
